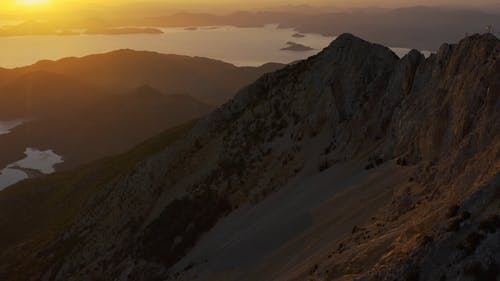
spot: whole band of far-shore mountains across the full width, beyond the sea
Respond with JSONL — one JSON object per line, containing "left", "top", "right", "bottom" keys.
{"left": 0, "top": 3, "right": 500, "bottom": 51}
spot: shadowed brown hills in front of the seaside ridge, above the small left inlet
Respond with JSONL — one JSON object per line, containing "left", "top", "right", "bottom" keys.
{"left": 0, "top": 72, "right": 212, "bottom": 169}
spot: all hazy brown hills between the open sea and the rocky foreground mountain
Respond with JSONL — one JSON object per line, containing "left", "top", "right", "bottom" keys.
{"left": 0, "top": 50, "right": 282, "bottom": 168}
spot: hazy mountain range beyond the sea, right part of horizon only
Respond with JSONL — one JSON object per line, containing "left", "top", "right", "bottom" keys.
{"left": 142, "top": 6, "right": 500, "bottom": 51}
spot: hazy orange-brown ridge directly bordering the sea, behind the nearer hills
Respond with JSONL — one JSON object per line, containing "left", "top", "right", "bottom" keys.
{"left": 0, "top": 49, "right": 283, "bottom": 105}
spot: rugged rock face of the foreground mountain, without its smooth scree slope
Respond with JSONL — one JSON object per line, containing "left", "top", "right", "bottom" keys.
{"left": 2, "top": 34, "right": 500, "bottom": 280}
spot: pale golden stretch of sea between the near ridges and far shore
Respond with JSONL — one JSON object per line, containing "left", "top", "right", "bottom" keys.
{"left": 0, "top": 25, "right": 428, "bottom": 68}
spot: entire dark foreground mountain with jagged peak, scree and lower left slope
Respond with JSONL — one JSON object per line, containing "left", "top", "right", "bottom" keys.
{"left": 0, "top": 34, "right": 500, "bottom": 281}
